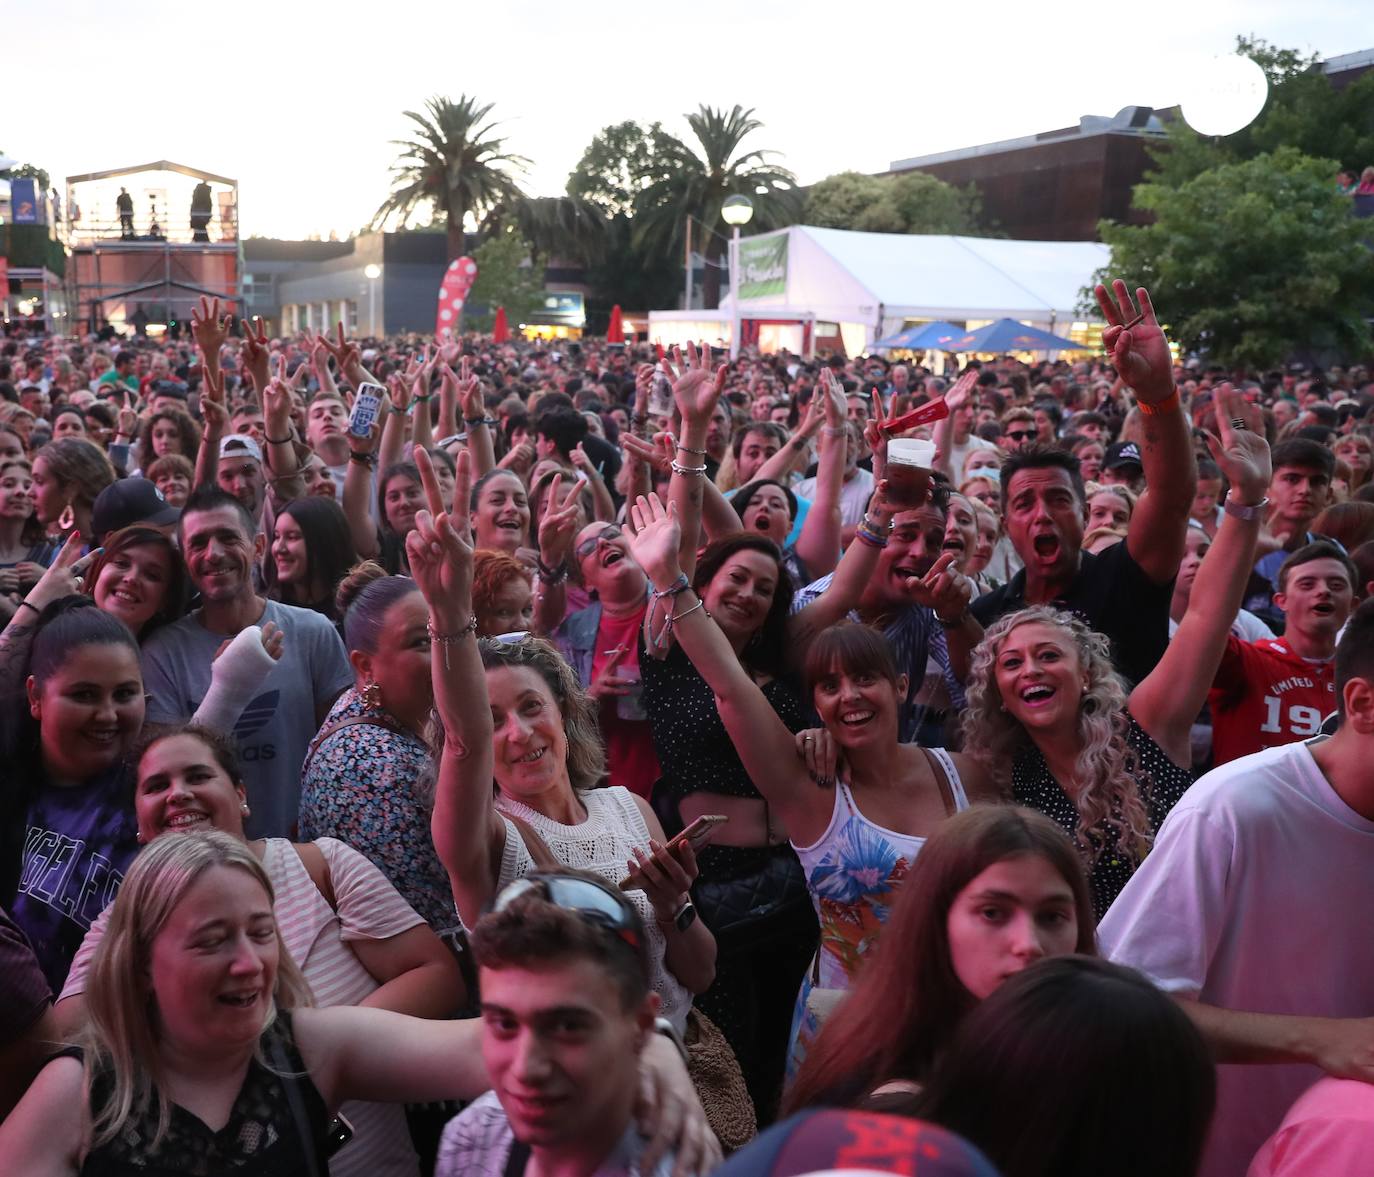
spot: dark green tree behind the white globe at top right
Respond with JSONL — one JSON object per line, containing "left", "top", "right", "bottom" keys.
{"left": 1147, "top": 37, "right": 1374, "bottom": 185}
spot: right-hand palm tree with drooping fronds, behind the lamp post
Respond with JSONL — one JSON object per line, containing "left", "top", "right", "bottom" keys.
{"left": 635, "top": 106, "right": 798, "bottom": 306}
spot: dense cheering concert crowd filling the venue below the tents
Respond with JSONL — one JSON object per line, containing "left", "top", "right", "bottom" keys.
{"left": 0, "top": 282, "right": 1374, "bottom": 1177}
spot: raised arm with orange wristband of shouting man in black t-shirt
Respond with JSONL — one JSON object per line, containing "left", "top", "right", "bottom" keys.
{"left": 1096, "top": 279, "right": 1198, "bottom": 584}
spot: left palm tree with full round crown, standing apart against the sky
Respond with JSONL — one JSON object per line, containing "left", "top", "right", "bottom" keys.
{"left": 371, "top": 93, "right": 529, "bottom": 261}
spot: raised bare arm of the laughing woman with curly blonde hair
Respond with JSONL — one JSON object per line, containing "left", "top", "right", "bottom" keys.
{"left": 1131, "top": 385, "right": 1270, "bottom": 765}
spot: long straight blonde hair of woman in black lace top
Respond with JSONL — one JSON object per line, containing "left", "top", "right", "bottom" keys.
{"left": 82, "top": 830, "right": 312, "bottom": 1150}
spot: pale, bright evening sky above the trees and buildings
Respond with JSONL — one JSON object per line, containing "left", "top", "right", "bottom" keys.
{"left": 10, "top": 0, "right": 1374, "bottom": 238}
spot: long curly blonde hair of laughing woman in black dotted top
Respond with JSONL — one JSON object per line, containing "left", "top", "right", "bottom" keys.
{"left": 962, "top": 604, "right": 1153, "bottom": 869}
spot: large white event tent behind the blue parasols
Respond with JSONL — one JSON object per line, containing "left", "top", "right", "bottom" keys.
{"left": 649, "top": 225, "right": 1110, "bottom": 356}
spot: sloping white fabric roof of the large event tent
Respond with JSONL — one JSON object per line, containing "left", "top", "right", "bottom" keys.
{"left": 769, "top": 225, "right": 1110, "bottom": 320}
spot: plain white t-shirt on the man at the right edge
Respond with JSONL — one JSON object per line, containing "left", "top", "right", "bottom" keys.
{"left": 1098, "top": 743, "right": 1374, "bottom": 1177}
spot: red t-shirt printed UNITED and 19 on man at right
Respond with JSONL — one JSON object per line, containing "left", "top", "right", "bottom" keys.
{"left": 1208, "top": 636, "right": 1336, "bottom": 765}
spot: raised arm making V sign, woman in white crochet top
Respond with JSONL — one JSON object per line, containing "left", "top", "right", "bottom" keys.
{"left": 405, "top": 450, "right": 506, "bottom": 927}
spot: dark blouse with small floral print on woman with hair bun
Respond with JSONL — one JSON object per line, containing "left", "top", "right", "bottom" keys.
{"left": 300, "top": 687, "right": 458, "bottom": 931}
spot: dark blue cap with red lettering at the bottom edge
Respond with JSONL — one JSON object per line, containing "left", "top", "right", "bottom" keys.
{"left": 716, "top": 1108, "right": 998, "bottom": 1177}
